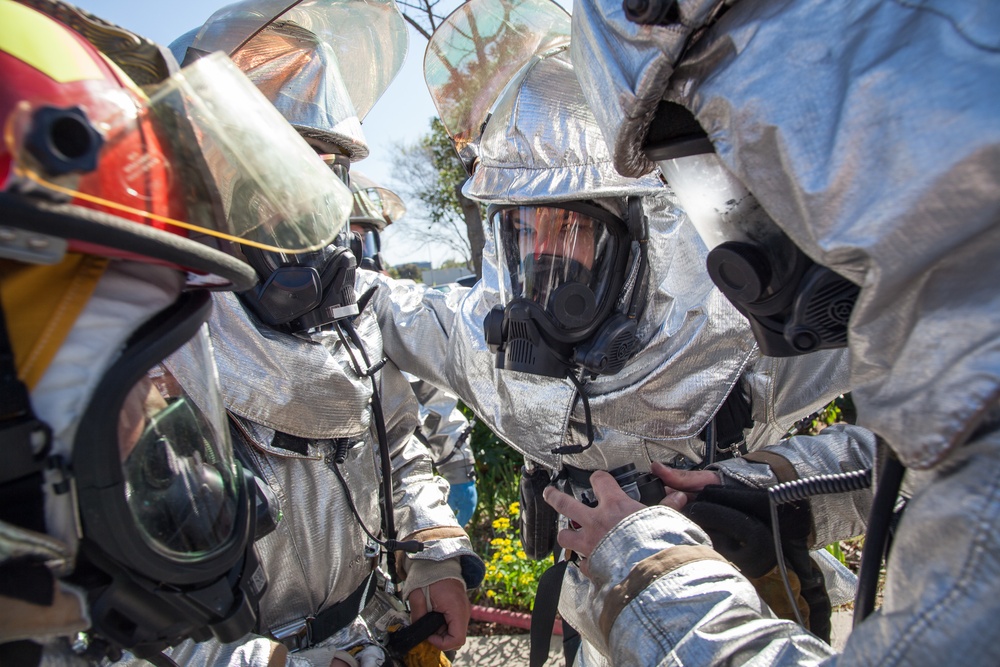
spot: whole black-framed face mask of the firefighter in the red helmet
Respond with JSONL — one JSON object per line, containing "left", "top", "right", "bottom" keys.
{"left": 72, "top": 292, "right": 265, "bottom": 656}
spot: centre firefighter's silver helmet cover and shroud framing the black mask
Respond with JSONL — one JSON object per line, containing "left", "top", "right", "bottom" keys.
{"left": 448, "top": 45, "right": 757, "bottom": 469}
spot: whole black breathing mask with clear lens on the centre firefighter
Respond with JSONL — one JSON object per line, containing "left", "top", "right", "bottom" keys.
{"left": 483, "top": 198, "right": 646, "bottom": 378}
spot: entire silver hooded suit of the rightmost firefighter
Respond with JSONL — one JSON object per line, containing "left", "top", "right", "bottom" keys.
{"left": 573, "top": 0, "right": 1000, "bottom": 665}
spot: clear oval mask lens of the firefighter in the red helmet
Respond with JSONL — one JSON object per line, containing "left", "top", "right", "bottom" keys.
{"left": 118, "top": 328, "right": 239, "bottom": 560}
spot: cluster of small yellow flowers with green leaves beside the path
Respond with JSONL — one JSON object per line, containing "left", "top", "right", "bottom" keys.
{"left": 477, "top": 502, "right": 552, "bottom": 611}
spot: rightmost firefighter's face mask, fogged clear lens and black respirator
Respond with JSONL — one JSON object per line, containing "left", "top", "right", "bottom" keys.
{"left": 644, "top": 103, "right": 859, "bottom": 357}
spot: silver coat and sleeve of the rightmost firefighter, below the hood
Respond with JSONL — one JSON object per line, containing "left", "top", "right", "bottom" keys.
{"left": 564, "top": 420, "right": 1000, "bottom": 667}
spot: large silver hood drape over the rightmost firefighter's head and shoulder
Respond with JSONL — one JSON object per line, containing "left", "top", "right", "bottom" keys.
{"left": 652, "top": 0, "right": 1000, "bottom": 468}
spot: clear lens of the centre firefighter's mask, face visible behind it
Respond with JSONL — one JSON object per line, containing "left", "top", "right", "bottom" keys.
{"left": 492, "top": 206, "right": 625, "bottom": 326}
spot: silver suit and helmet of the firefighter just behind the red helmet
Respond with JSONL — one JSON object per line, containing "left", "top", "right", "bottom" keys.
{"left": 155, "top": 1, "right": 484, "bottom": 665}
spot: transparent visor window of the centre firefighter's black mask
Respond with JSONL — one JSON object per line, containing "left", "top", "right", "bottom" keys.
{"left": 489, "top": 203, "right": 627, "bottom": 330}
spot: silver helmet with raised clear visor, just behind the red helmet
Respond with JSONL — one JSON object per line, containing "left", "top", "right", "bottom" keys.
{"left": 171, "top": 0, "right": 408, "bottom": 161}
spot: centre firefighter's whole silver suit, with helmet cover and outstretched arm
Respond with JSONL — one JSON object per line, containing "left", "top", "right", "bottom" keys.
{"left": 359, "top": 43, "right": 874, "bottom": 664}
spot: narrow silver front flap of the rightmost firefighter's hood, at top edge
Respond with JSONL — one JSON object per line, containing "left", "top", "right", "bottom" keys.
{"left": 570, "top": 0, "right": 728, "bottom": 177}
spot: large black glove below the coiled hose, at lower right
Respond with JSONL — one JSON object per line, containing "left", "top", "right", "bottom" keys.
{"left": 681, "top": 481, "right": 831, "bottom": 642}
